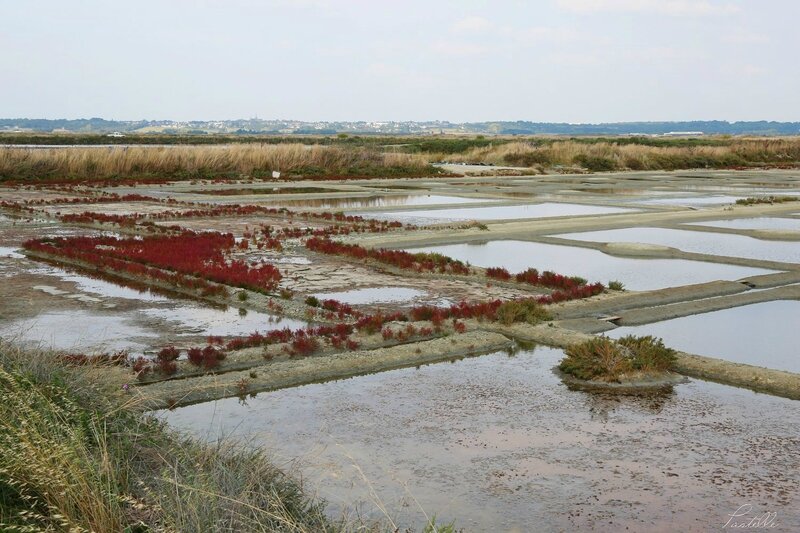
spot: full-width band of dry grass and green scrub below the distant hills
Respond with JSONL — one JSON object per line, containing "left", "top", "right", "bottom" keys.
{"left": 0, "top": 136, "right": 800, "bottom": 182}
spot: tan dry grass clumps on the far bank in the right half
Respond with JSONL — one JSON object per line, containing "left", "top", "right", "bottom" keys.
{"left": 446, "top": 139, "right": 800, "bottom": 170}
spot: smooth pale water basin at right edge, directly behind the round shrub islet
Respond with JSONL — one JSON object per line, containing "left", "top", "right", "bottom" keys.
{"left": 608, "top": 300, "right": 800, "bottom": 372}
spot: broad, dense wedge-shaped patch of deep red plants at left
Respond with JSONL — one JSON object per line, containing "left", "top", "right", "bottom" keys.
{"left": 23, "top": 230, "right": 281, "bottom": 292}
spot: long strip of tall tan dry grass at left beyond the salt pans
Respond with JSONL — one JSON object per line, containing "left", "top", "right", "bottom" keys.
{"left": 0, "top": 144, "right": 432, "bottom": 181}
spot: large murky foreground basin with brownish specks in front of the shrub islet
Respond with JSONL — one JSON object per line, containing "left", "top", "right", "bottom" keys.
{"left": 160, "top": 348, "right": 800, "bottom": 531}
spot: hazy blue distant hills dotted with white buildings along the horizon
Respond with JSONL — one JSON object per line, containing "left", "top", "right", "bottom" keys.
{"left": 0, "top": 118, "right": 800, "bottom": 136}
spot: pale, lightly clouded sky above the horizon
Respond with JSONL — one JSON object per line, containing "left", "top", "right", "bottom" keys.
{"left": 0, "top": 0, "right": 800, "bottom": 123}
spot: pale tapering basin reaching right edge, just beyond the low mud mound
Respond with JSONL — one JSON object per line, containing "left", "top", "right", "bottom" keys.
{"left": 557, "top": 228, "right": 800, "bottom": 263}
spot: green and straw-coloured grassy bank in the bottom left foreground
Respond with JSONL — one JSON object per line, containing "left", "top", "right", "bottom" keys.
{"left": 0, "top": 342, "right": 334, "bottom": 532}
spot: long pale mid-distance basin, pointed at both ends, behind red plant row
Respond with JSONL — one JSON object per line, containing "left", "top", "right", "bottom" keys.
{"left": 409, "top": 241, "right": 773, "bottom": 291}
